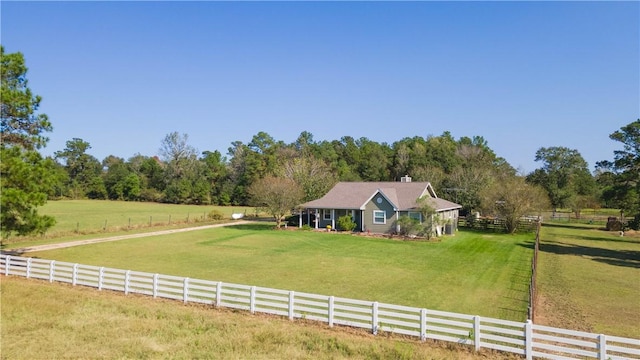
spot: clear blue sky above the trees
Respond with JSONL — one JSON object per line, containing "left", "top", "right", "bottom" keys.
{"left": 0, "top": 1, "right": 640, "bottom": 172}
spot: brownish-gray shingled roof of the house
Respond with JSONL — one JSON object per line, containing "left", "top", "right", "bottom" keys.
{"left": 300, "top": 182, "right": 462, "bottom": 211}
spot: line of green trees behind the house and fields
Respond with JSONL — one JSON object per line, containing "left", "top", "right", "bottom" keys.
{"left": 0, "top": 48, "right": 640, "bottom": 237}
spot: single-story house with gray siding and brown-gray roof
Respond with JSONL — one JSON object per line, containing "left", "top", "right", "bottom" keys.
{"left": 298, "top": 176, "right": 462, "bottom": 235}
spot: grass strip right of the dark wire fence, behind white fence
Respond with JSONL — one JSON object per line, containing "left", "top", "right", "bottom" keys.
{"left": 535, "top": 224, "right": 640, "bottom": 339}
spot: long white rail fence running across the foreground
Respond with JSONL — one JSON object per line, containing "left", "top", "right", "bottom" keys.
{"left": 0, "top": 254, "right": 640, "bottom": 360}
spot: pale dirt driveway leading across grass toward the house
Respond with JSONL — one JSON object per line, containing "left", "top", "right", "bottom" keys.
{"left": 2, "top": 220, "right": 252, "bottom": 255}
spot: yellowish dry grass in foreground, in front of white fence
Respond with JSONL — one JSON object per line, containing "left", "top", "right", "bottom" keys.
{"left": 0, "top": 276, "right": 518, "bottom": 360}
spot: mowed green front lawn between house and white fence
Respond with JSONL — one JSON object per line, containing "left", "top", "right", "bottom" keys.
{"left": 29, "top": 223, "right": 533, "bottom": 321}
